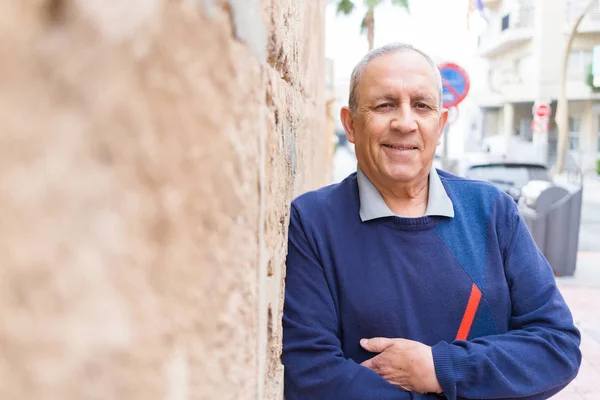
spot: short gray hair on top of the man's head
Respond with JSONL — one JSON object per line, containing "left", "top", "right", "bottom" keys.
{"left": 348, "top": 43, "right": 443, "bottom": 115}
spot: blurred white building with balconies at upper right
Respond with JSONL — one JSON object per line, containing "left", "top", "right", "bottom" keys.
{"left": 473, "top": 0, "right": 600, "bottom": 171}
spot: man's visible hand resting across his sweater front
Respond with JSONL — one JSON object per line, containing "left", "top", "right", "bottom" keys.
{"left": 360, "top": 338, "right": 442, "bottom": 394}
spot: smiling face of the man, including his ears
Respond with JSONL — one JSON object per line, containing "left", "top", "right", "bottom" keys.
{"left": 342, "top": 51, "right": 448, "bottom": 183}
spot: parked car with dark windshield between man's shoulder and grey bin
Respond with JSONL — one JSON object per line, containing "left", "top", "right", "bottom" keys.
{"left": 459, "top": 155, "right": 552, "bottom": 201}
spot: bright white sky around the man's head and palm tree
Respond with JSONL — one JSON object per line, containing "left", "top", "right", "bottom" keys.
{"left": 325, "top": 0, "right": 486, "bottom": 155}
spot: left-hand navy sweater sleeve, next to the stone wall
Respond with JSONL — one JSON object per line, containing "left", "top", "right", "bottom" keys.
{"left": 282, "top": 205, "right": 439, "bottom": 400}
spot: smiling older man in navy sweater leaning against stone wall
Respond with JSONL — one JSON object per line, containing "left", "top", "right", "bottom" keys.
{"left": 282, "top": 44, "right": 581, "bottom": 400}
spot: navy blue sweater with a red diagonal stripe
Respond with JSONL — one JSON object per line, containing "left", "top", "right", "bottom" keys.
{"left": 282, "top": 171, "right": 581, "bottom": 400}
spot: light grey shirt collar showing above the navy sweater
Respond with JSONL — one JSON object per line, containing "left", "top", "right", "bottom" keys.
{"left": 356, "top": 167, "right": 454, "bottom": 222}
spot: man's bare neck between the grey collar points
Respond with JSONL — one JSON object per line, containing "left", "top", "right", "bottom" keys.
{"left": 363, "top": 171, "right": 429, "bottom": 218}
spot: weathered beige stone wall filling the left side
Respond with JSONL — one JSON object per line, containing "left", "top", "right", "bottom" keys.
{"left": 0, "top": 0, "right": 331, "bottom": 400}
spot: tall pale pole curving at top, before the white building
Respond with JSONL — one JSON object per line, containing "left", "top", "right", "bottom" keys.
{"left": 555, "top": 0, "right": 598, "bottom": 174}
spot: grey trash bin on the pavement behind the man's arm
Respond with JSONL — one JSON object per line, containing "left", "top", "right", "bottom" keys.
{"left": 519, "top": 181, "right": 583, "bottom": 276}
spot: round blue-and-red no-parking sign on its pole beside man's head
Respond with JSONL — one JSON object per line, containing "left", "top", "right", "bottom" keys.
{"left": 438, "top": 63, "right": 471, "bottom": 168}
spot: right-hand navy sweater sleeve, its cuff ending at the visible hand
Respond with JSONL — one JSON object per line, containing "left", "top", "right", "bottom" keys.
{"left": 433, "top": 198, "right": 581, "bottom": 400}
